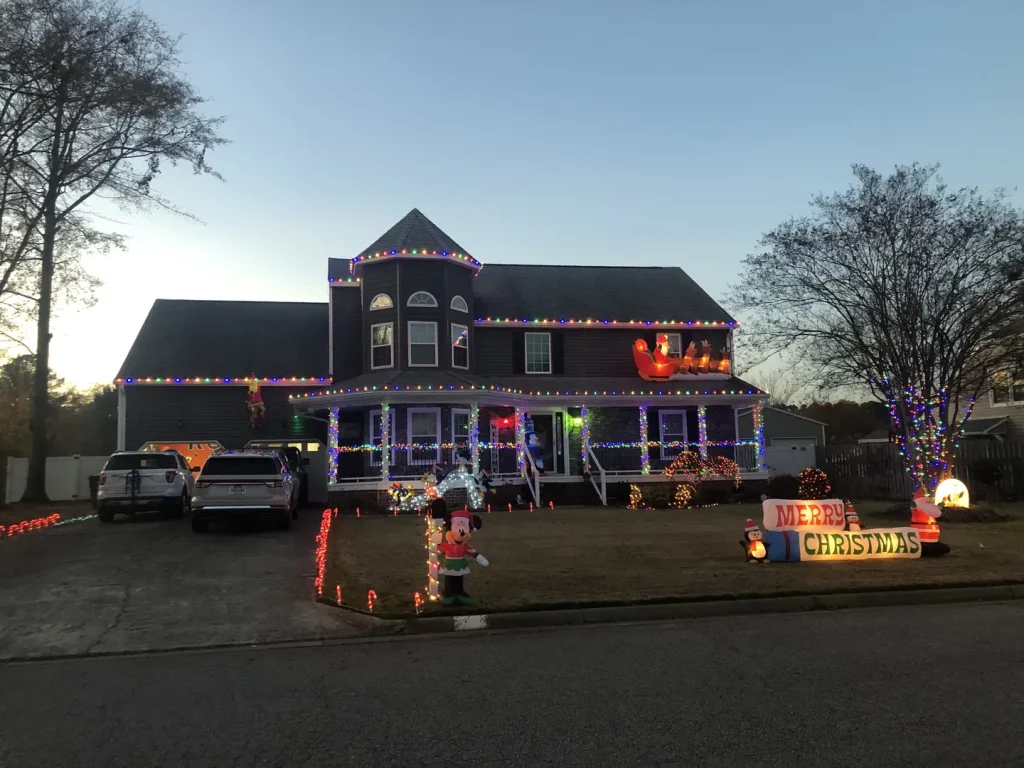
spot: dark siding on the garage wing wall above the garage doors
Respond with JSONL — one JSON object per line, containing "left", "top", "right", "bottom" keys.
{"left": 125, "top": 385, "right": 327, "bottom": 450}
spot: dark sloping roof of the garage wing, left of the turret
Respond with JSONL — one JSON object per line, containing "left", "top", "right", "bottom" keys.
{"left": 118, "top": 299, "right": 330, "bottom": 379}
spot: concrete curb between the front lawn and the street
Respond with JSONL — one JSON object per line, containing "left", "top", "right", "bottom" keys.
{"left": 404, "top": 584, "right": 1024, "bottom": 635}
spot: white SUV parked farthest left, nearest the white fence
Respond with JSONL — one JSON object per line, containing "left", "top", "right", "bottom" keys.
{"left": 96, "top": 451, "right": 199, "bottom": 522}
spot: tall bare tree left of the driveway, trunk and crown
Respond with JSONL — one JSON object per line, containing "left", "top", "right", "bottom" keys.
{"left": 0, "top": 0, "right": 223, "bottom": 500}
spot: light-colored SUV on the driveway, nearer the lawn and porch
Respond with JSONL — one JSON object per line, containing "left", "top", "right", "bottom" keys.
{"left": 191, "top": 451, "right": 299, "bottom": 534}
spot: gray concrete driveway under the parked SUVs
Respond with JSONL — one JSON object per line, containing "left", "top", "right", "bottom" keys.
{"left": 0, "top": 509, "right": 359, "bottom": 659}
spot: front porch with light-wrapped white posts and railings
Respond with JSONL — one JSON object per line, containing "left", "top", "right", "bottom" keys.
{"left": 306, "top": 392, "right": 768, "bottom": 509}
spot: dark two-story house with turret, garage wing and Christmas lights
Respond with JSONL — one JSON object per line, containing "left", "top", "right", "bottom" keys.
{"left": 117, "top": 209, "right": 767, "bottom": 506}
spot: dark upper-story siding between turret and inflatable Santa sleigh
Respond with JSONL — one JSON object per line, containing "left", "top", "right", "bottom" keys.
{"left": 475, "top": 328, "right": 728, "bottom": 377}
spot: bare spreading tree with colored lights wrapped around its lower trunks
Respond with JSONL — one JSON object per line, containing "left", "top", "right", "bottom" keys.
{"left": 733, "top": 165, "right": 1024, "bottom": 495}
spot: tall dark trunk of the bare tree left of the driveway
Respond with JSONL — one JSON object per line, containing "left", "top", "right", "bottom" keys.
{"left": 24, "top": 204, "right": 57, "bottom": 502}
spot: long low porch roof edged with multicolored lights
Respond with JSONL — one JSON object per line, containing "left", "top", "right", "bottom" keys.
{"left": 292, "top": 371, "right": 765, "bottom": 410}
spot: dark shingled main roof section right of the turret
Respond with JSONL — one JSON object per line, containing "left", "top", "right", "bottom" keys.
{"left": 473, "top": 264, "right": 735, "bottom": 323}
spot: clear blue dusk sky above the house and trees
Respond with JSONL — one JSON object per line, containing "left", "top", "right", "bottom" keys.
{"left": 53, "top": 0, "right": 1024, "bottom": 384}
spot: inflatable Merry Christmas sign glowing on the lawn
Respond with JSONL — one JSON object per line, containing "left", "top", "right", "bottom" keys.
{"left": 762, "top": 499, "right": 922, "bottom": 562}
